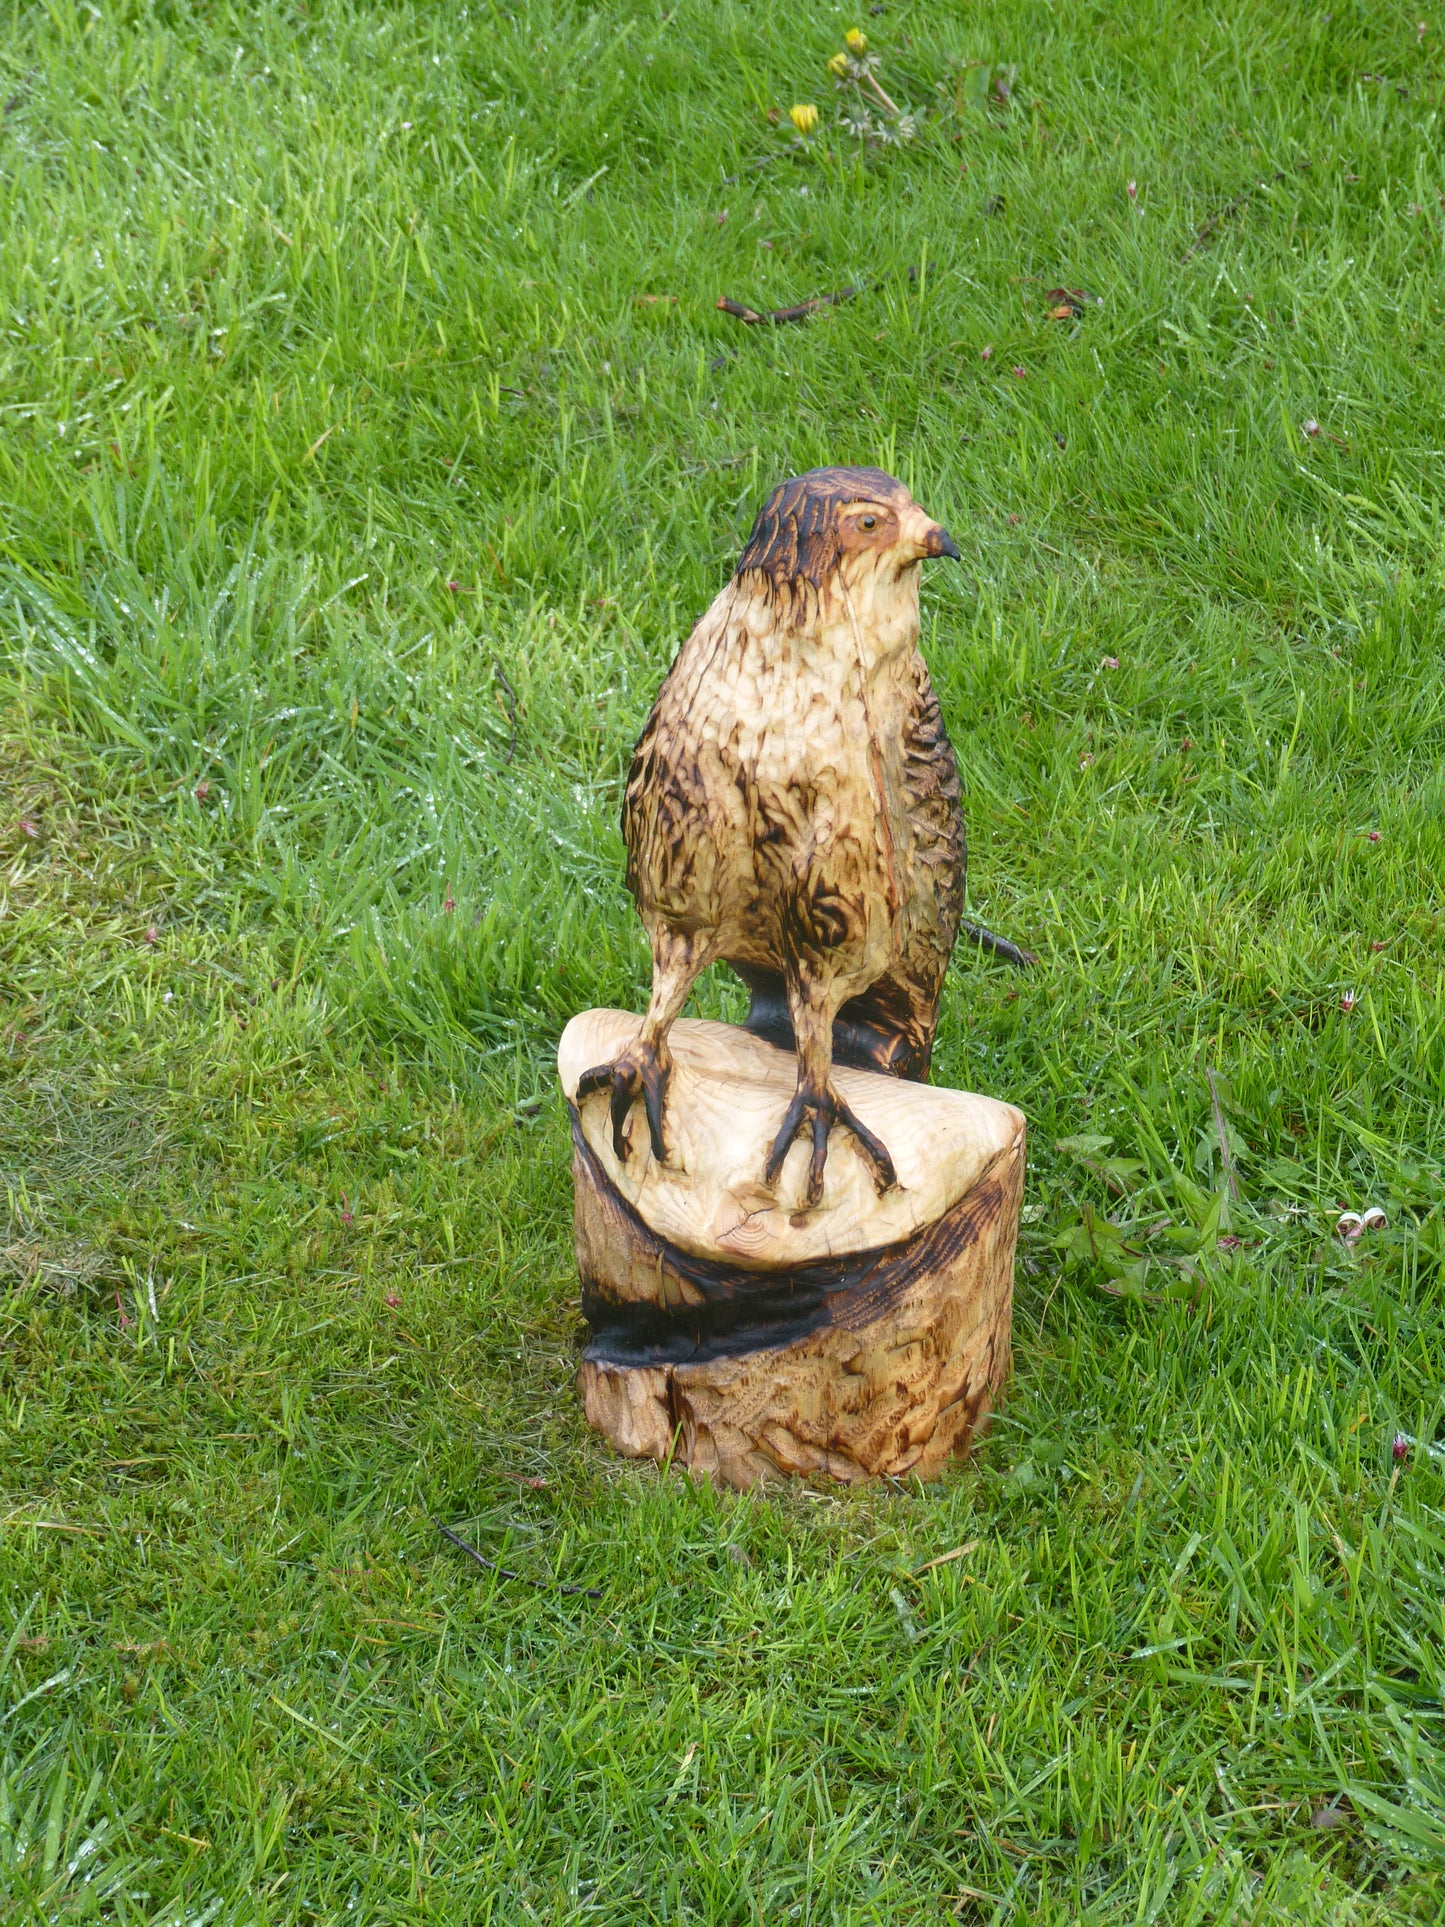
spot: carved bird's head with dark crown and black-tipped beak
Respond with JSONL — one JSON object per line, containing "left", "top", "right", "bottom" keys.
{"left": 736, "top": 468, "right": 959, "bottom": 619}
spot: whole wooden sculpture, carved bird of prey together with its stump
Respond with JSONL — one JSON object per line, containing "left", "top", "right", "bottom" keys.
{"left": 557, "top": 470, "right": 1025, "bottom": 1486}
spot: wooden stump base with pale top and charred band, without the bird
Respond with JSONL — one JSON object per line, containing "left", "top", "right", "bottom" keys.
{"left": 557, "top": 1010, "right": 1025, "bottom": 1488}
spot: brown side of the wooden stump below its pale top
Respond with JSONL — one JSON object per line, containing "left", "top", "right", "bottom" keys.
{"left": 572, "top": 1112, "right": 1023, "bottom": 1490}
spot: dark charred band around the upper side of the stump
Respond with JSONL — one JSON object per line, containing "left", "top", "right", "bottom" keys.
{"left": 568, "top": 1104, "right": 1017, "bottom": 1368}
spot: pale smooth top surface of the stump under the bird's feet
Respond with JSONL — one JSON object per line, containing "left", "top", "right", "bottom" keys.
{"left": 557, "top": 1010, "right": 1025, "bottom": 1272}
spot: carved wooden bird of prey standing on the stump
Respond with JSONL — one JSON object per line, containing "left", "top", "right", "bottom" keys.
{"left": 578, "top": 468, "right": 965, "bottom": 1206}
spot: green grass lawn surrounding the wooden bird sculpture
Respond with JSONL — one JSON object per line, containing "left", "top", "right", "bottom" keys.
{"left": 0, "top": 0, "right": 1445, "bottom": 1927}
